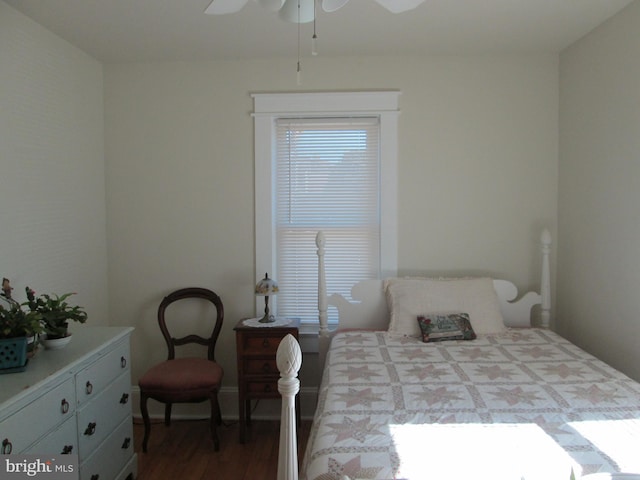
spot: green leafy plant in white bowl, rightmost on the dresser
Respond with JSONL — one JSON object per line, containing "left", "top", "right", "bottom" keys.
{"left": 23, "top": 287, "right": 87, "bottom": 348}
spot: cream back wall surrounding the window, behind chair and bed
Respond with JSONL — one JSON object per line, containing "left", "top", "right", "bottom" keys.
{"left": 104, "top": 55, "right": 558, "bottom": 416}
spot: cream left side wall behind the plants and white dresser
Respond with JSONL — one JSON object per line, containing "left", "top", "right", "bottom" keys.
{"left": 0, "top": 2, "right": 108, "bottom": 328}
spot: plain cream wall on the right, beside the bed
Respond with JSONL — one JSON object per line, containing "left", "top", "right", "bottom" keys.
{"left": 557, "top": 2, "right": 640, "bottom": 380}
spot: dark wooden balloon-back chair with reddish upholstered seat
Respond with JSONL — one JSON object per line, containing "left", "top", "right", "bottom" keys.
{"left": 138, "top": 287, "right": 224, "bottom": 452}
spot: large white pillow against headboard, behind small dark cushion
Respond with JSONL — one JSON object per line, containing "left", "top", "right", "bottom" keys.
{"left": 384, "top": 277, "right": 506, "bottom": 337}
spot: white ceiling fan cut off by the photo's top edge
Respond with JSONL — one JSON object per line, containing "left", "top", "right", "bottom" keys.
{"left": 204, "top": 0, "right": 425, "bottom": 23}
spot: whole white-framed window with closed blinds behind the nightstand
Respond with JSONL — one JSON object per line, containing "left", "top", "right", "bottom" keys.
{"left": 254, "top": 92, "right": 398, "bottom": 331}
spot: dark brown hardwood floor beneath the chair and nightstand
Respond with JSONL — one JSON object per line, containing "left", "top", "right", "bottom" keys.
{"left": 133, "top": 419, "right": 311, "bottom": 480}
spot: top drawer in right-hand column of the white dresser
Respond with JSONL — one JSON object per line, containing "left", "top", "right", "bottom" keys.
{"left": 76, "top": 342, "right": 129, "bottom": 406}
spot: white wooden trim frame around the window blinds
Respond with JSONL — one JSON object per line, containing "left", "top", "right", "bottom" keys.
{"left": 251, "top": 91, "right": 400, "bottom": 333}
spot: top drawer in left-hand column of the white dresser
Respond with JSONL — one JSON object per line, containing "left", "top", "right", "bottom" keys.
{"left": 0, "top": 376, "right": 75, "bottom": 453}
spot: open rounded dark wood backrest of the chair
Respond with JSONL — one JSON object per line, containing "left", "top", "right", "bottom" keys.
{"left": 158, "top": 287, "right": 224, "bottom": 361}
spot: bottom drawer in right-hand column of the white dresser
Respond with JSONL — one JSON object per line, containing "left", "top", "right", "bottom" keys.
{"left": 80, "top": 418, "right": 133, "bottom": 480}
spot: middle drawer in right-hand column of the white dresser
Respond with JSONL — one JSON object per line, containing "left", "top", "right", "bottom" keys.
{"left": 78, "top": 372, "right": 131, "bottom": 458}
